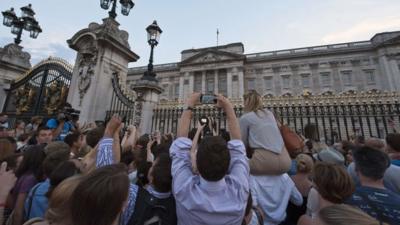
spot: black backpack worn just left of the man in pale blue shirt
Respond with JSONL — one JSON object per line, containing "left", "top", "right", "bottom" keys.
{"left": 128, "top": 187, "right": 177, "bottom": 225}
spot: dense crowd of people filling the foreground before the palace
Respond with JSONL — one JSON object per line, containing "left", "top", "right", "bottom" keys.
{"left": 0, "top": 91, "right": 400, "bottom": 225}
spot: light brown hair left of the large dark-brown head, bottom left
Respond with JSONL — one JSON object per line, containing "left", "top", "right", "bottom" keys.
{"left": 45, "top": 175, "right": 82, "bottom": 223}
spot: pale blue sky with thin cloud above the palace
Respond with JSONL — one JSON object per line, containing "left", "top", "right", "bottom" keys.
{"left": 0, "top": 0, "right": 400, "bottom": 66}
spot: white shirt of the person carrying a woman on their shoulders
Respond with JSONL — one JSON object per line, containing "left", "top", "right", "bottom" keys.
{"left": 250, "top": 173, "right": 303, "bottom": 225}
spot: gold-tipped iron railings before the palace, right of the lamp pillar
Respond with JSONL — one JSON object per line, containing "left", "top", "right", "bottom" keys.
{"left": 151, "top": 91, "right": 400, "bottom": 143}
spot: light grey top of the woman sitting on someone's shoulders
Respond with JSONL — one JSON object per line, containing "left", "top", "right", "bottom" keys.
{"left": 240, "top": 109, "right": 284, "bottom": 154}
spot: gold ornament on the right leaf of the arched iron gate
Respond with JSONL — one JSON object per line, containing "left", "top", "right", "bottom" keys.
{"left": 45, "top": 80, "right": 68, "bottom": 115}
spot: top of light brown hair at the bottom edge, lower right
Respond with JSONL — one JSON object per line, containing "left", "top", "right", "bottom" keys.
{"left": 319, "top": 204, "right": 387, "bottom": 225}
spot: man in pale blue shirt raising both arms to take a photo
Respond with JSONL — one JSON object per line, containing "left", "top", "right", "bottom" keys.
{"left": 170, "top": 93, "right": 249, "bottom": 225}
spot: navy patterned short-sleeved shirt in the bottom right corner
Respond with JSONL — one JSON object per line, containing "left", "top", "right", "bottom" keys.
{"left": 347, "top": 186, "right": 400, "bottom": 225}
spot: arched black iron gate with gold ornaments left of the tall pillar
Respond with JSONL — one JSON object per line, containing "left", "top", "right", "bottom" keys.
{"left": 3, "top": 57, "right": 72, "bottom": 124}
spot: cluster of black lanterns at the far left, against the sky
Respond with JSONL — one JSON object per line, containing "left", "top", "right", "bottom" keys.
{"left": 2, "top": 4, "right": 42, "bottom": 45}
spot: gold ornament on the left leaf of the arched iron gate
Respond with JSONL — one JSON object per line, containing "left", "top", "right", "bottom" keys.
{"left": 15, "top": 85, "right": 36, "bottom": 115}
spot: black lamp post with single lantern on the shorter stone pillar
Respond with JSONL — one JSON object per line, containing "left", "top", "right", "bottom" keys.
{"left": 142, "top": 20, "right": 162, "bottom": 82}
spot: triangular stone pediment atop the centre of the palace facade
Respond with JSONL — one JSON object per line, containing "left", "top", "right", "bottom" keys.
{"left": 181, "top": 50, "right": 245, "bottom": 65}
